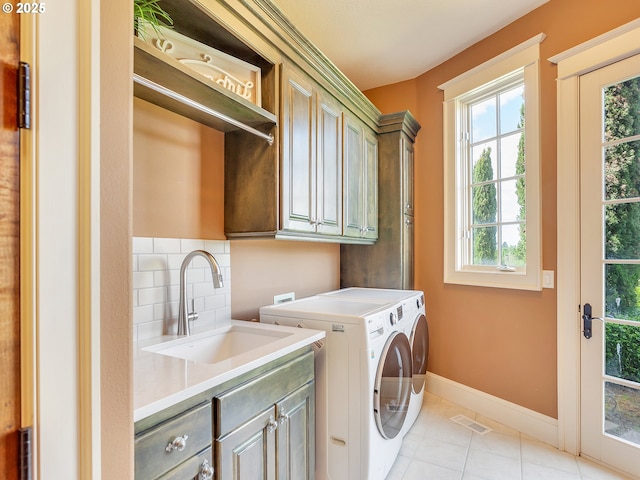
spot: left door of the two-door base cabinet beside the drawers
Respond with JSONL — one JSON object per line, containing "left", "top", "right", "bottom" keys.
{"left": 215, "top": 407, "right": 278, "bottom": 480}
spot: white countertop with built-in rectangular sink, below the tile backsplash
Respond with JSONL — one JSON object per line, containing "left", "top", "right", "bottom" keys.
{"left": 133, "top": 319, "right": 326, "bottom": 422}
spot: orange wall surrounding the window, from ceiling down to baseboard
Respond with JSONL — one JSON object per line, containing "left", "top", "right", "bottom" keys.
{"left": 365, "top": 0, "right": 640, "bottom": 418}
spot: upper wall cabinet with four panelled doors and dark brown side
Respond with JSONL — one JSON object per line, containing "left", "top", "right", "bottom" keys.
{"left": 225, "top": 62, "right": 378, "bottom": 243}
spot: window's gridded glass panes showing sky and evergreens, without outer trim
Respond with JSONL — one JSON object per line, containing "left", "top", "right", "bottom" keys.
{"left": 468, "top": 83, "right": 526, "bottom": 269}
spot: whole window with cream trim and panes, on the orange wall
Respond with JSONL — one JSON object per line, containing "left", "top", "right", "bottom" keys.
{"left": 440, "top": 35, "right": 544, "bottom": 290}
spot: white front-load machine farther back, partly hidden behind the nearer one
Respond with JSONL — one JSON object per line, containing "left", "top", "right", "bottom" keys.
{"left": 319, "top": 287, "right": 429, "bottom": 436}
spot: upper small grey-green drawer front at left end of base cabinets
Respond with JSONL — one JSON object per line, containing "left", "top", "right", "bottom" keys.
{"left": 135, "top": 402, "right": 212, "bottom": 480}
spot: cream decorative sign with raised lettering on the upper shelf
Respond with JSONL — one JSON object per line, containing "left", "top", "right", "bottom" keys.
{"left": 141, "top": 25, "right": 262, "bottom": 107}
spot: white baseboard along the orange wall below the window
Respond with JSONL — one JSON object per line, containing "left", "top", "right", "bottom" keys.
{"left": 426, "top": 372, "right": 558, "bottom": 448}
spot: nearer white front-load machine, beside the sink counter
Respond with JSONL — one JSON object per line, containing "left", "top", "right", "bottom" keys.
{"left": 260, "top": 296, "right": 412, "bottom": 480}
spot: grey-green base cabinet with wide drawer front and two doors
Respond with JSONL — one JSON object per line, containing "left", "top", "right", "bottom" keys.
{"left": 213, "top": 352, "right": 315, "bottom": 480}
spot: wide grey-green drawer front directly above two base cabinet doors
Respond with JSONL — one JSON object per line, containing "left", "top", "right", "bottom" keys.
{"left": 213, "top": 351, "right": 314, "bottom": 438}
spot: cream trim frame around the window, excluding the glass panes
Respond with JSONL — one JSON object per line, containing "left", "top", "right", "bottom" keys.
{"left": 438, "top": 34, "right": 544, "bottom": 290}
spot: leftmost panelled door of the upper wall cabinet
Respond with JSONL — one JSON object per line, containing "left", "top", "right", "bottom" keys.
{"left": 280, "top": 68, "right": 316, "bottom": 232}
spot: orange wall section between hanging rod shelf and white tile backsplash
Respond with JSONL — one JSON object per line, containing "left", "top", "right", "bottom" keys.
{"left": 133, "top": 98, "right": 226, "bottom": 240}
